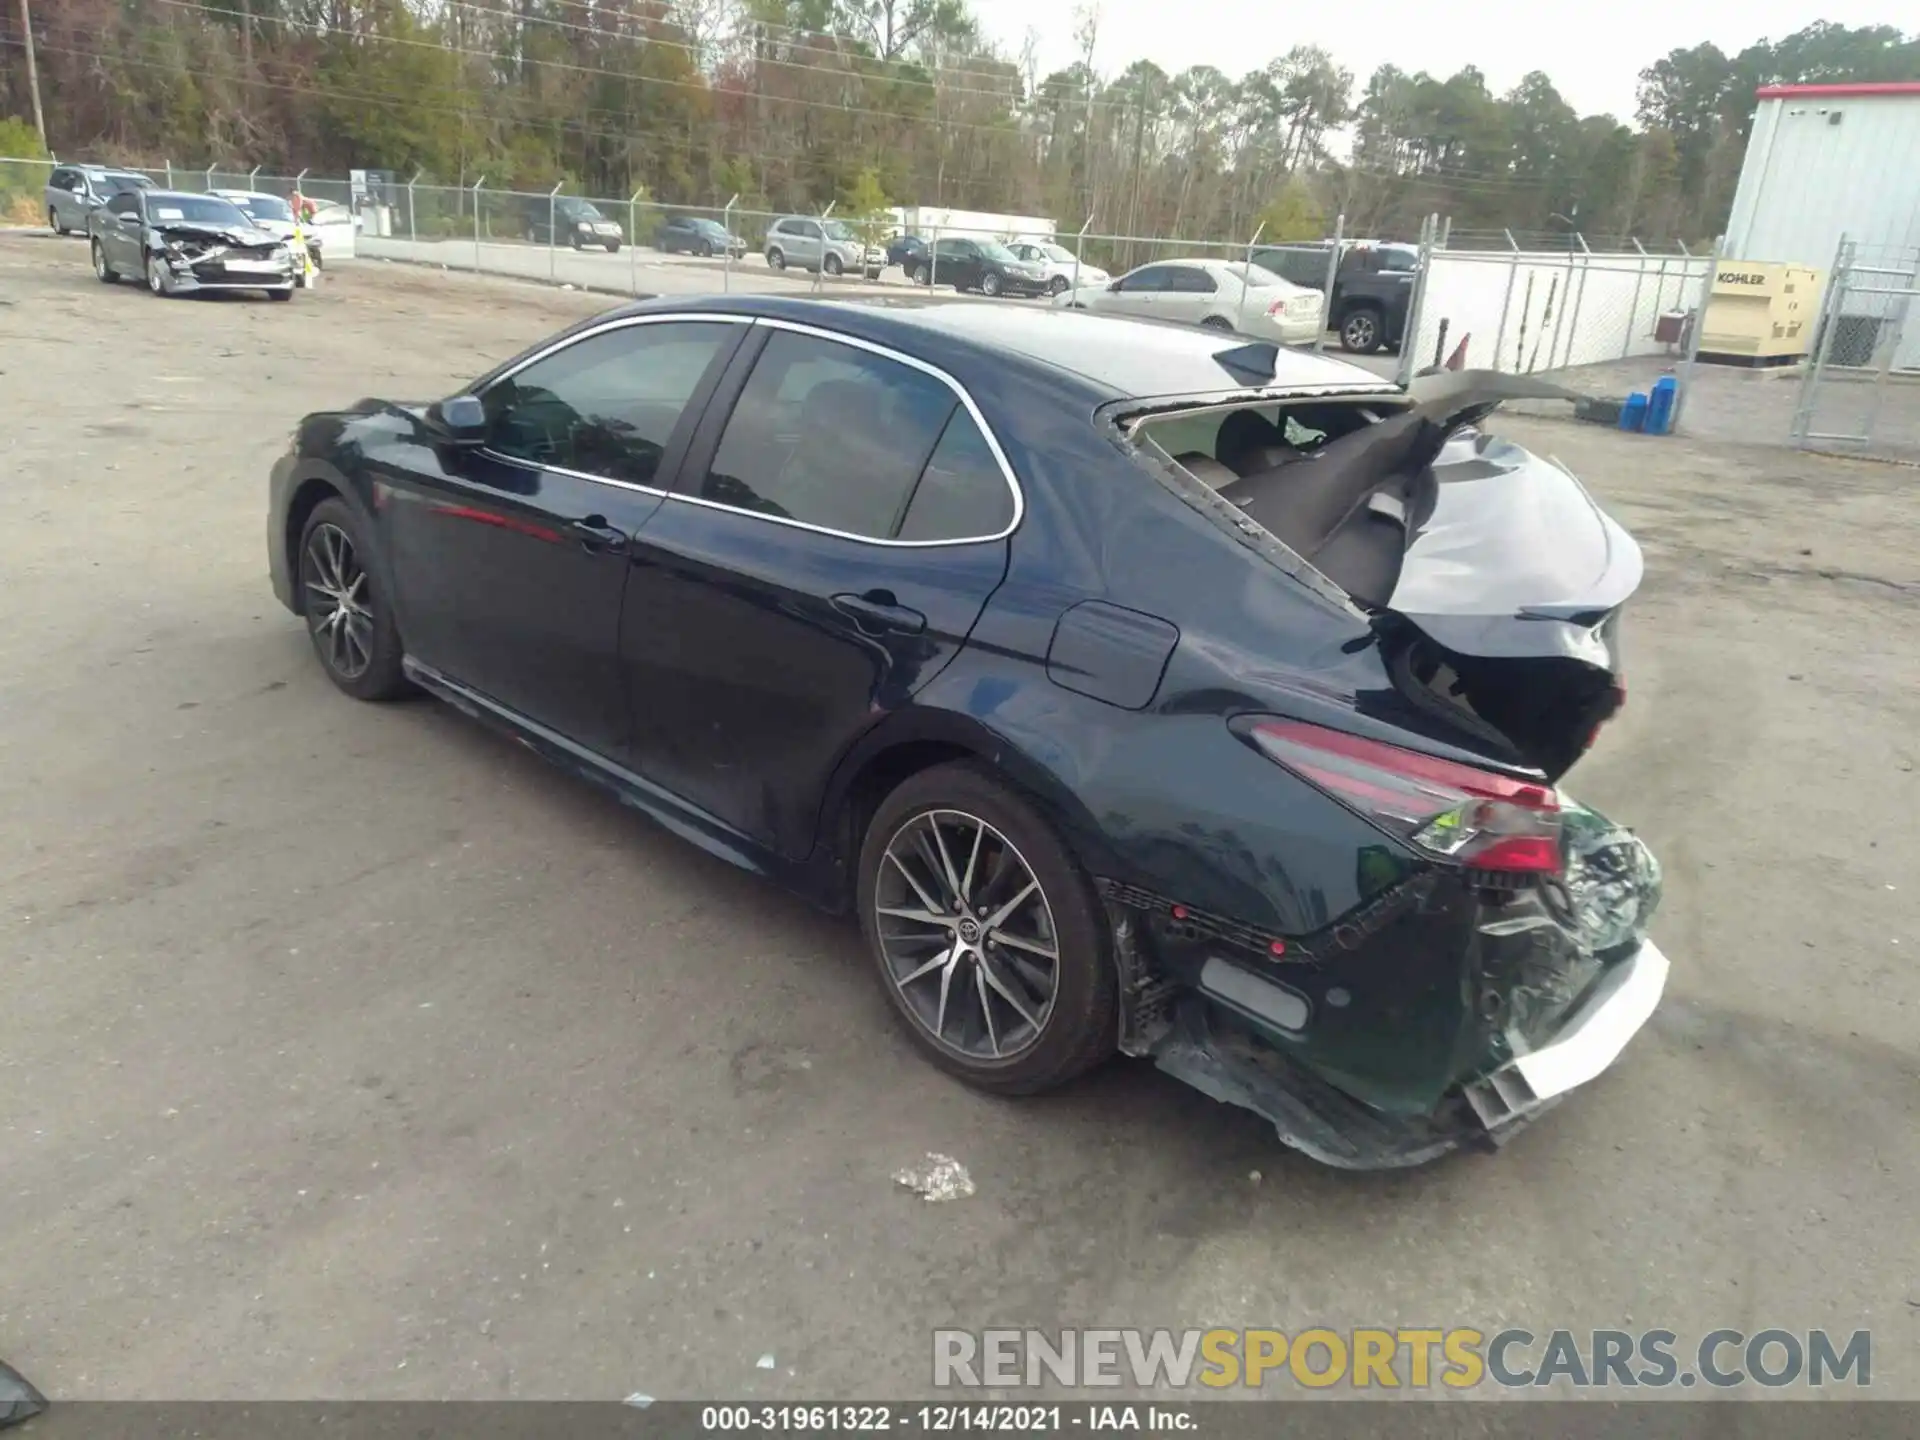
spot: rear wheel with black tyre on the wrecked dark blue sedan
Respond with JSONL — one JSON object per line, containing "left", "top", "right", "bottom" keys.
{"left": 858, "top": 762, "right": 1119, "bottom": 1094}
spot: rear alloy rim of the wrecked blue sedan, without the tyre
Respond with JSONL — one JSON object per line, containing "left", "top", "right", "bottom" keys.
{"left": 874, "top": 810, "right": 1060, "bottom": 1062}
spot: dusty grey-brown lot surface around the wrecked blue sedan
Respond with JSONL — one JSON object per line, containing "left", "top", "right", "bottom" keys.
{"left": 0, "top": 234, "right": 1920, "bottom": 1400}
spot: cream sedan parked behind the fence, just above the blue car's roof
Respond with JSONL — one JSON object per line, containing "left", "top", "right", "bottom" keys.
{"left": 1054, "top": 259, "right": 1323, "bottom": 346}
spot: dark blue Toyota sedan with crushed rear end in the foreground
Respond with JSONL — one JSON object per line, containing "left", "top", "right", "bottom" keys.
{"left": 267, "top": 296, "right": 1667, "bottom": 1167}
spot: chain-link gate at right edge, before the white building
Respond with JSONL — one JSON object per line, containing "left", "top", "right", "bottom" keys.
{"left": 1793, "top": 240, "right": 1920, "bottom": 465}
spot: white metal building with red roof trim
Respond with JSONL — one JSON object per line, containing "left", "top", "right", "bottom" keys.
{"left": 1724, "top": 81, "right": 1920, "bottom": 369}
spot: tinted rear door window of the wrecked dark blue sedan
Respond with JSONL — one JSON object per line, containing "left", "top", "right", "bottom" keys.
{"left": 699, "top": 330, "right": 967, "bottom": 540}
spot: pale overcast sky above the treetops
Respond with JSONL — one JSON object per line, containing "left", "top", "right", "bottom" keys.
{"left": 972, "top": 0, "right": 1910, "bottom": 121}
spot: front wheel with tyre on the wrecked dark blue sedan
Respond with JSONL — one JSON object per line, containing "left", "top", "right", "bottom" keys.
{"left": 300, "top": 499, "right": 407, "bottom": 701}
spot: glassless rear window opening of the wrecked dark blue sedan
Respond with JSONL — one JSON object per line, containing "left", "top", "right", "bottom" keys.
{"left": 1131, "top": 397, "right": 1438, "bottom": 609}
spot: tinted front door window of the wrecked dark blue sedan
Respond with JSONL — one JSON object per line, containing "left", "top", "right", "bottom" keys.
{"left": 480, "top": 321, "right": 739, "bottom": 486}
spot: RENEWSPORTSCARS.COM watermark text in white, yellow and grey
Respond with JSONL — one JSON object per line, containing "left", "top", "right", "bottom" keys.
{"left": 933, "top": 1327, "right": 1874, "bottom": 1394}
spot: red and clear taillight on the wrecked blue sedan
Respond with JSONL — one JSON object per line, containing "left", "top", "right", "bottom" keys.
{"left": 1236, "top": 720, "right": 1561, "bottom": 876}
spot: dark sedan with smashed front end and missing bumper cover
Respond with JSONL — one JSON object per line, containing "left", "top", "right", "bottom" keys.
{"left": 86, "top": 190, "right": 296, "bottom": 300}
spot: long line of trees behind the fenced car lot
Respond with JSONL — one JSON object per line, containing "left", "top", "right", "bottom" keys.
{"left": 0, "top": 0, "right": 1920, "bottom": 244}
